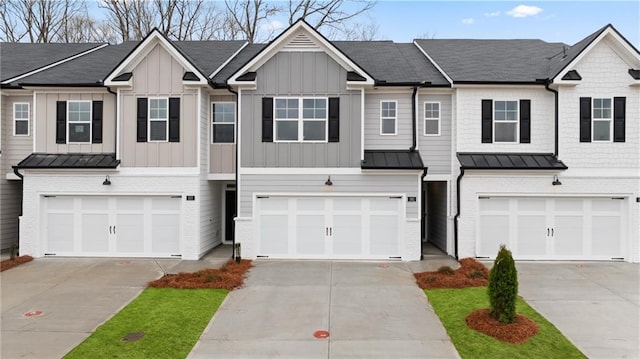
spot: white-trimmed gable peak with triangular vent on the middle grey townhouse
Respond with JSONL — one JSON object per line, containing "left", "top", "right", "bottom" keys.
{"left": 228, "top": 19, "right": 374, "bottom": 85}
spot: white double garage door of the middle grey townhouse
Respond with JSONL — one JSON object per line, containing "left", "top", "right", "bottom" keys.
{"left": 257, "top": 197, "right": 402, "bottom": 259}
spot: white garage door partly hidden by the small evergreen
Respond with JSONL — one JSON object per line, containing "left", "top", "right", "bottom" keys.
{"left": 477, "top": 197, "right": 626, "bottom": 260}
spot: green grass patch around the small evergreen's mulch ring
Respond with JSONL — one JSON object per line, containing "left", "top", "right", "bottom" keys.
{"left": 425, "top": 287, "right": 586, "bottom": 359}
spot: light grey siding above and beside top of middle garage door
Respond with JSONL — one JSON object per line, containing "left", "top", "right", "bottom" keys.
{"left": 238, "top": 174, "right": 419, "bottom": 218}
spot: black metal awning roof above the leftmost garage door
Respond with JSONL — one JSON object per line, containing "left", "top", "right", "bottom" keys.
{"left": 15, "top": 153, "right": 120, "bottom": 169}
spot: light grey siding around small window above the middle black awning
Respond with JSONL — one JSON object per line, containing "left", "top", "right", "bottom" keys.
{"left": 364, "top": 91, "right": 413, "bottom": 150}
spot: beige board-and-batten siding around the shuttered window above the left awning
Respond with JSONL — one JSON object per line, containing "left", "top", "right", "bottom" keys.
{"left": 31, "top": 90, "right": 116, "bottom": 153}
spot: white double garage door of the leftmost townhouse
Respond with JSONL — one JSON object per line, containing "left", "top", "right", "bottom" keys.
{"left": 43, "top": 196, "right": 180, "bottom": 257}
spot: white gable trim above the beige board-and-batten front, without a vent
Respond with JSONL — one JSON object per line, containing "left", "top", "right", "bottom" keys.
{"left": 104, "top": 28, "right": 208, "bottom": 86}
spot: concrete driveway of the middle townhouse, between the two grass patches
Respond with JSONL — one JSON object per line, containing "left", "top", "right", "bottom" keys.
{"left": 189, "top": 260, "right": 458, "bottom": 358}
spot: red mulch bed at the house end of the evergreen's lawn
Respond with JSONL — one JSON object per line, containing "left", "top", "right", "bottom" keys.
{"left": 414, "top": 258, "right": 489, "bottom": 289}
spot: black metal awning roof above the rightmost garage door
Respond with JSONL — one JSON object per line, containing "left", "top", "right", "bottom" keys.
{"left": 457, "top": 152, "right": 568, "bottom": 170}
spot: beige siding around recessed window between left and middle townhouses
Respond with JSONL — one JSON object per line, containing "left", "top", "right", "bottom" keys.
{"left": 210, "top": 95, "right": 237, "bottom": 174}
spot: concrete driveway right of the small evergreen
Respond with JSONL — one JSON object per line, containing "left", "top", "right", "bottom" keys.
{"left": 516, "top": 262, "right": 640, "bottom": 359}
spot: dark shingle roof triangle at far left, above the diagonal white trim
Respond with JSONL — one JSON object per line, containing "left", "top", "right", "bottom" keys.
{"left": 0, "top": 43, "right": 102, "bottom": 81}
